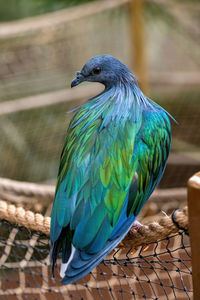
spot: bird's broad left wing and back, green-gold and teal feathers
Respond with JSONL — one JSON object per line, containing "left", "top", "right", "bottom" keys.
{"left": 51, "top": 103, "right": 141, "bottom": 248}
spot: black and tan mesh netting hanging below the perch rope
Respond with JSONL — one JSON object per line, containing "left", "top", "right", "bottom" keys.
{"left": 0, "top": 221, "right": 192, "bottom": 300}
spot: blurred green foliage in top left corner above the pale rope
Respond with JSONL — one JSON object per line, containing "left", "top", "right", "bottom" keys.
{"left": 0, "top": 0, "right": 94, "bottom": 22}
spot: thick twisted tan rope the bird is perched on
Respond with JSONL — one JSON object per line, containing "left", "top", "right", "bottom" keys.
{"left": 0, "top": 201, "right": 188, "bottom": 248}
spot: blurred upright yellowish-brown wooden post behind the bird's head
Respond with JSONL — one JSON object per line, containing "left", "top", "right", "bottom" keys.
{"left": 130, "top": 0, "right": 149, "bottom": 93}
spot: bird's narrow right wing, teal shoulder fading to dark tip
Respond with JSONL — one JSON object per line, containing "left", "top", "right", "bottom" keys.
{"left": 127, "top": 110, "right": 171, "bottom": 216}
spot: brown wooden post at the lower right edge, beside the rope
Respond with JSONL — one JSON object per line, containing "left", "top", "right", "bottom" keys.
{"left": 188, "top": 172, "right": 200, "bottom": 300}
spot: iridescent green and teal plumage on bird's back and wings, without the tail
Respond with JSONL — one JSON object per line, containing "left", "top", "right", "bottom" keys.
{"left": 52, "top": 85, "right": 170, "bottom": 248}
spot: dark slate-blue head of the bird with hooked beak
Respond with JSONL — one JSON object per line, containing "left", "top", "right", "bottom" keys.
{"left": 71, "top": 54, "right": 136, "bottom": 88}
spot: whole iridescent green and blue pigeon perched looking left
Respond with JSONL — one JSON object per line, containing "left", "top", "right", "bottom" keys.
{"left": 50, "top": 54, "right": 174, "bottom": 284}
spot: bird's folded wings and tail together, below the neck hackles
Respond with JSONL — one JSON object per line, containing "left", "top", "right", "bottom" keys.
{"left": 51, "top": 101, "right": 170, "bottom": 283}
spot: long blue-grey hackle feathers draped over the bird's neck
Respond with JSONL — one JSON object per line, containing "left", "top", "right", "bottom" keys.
{"left": 70, "top": 83, "right": 158, "bottom": 132}
